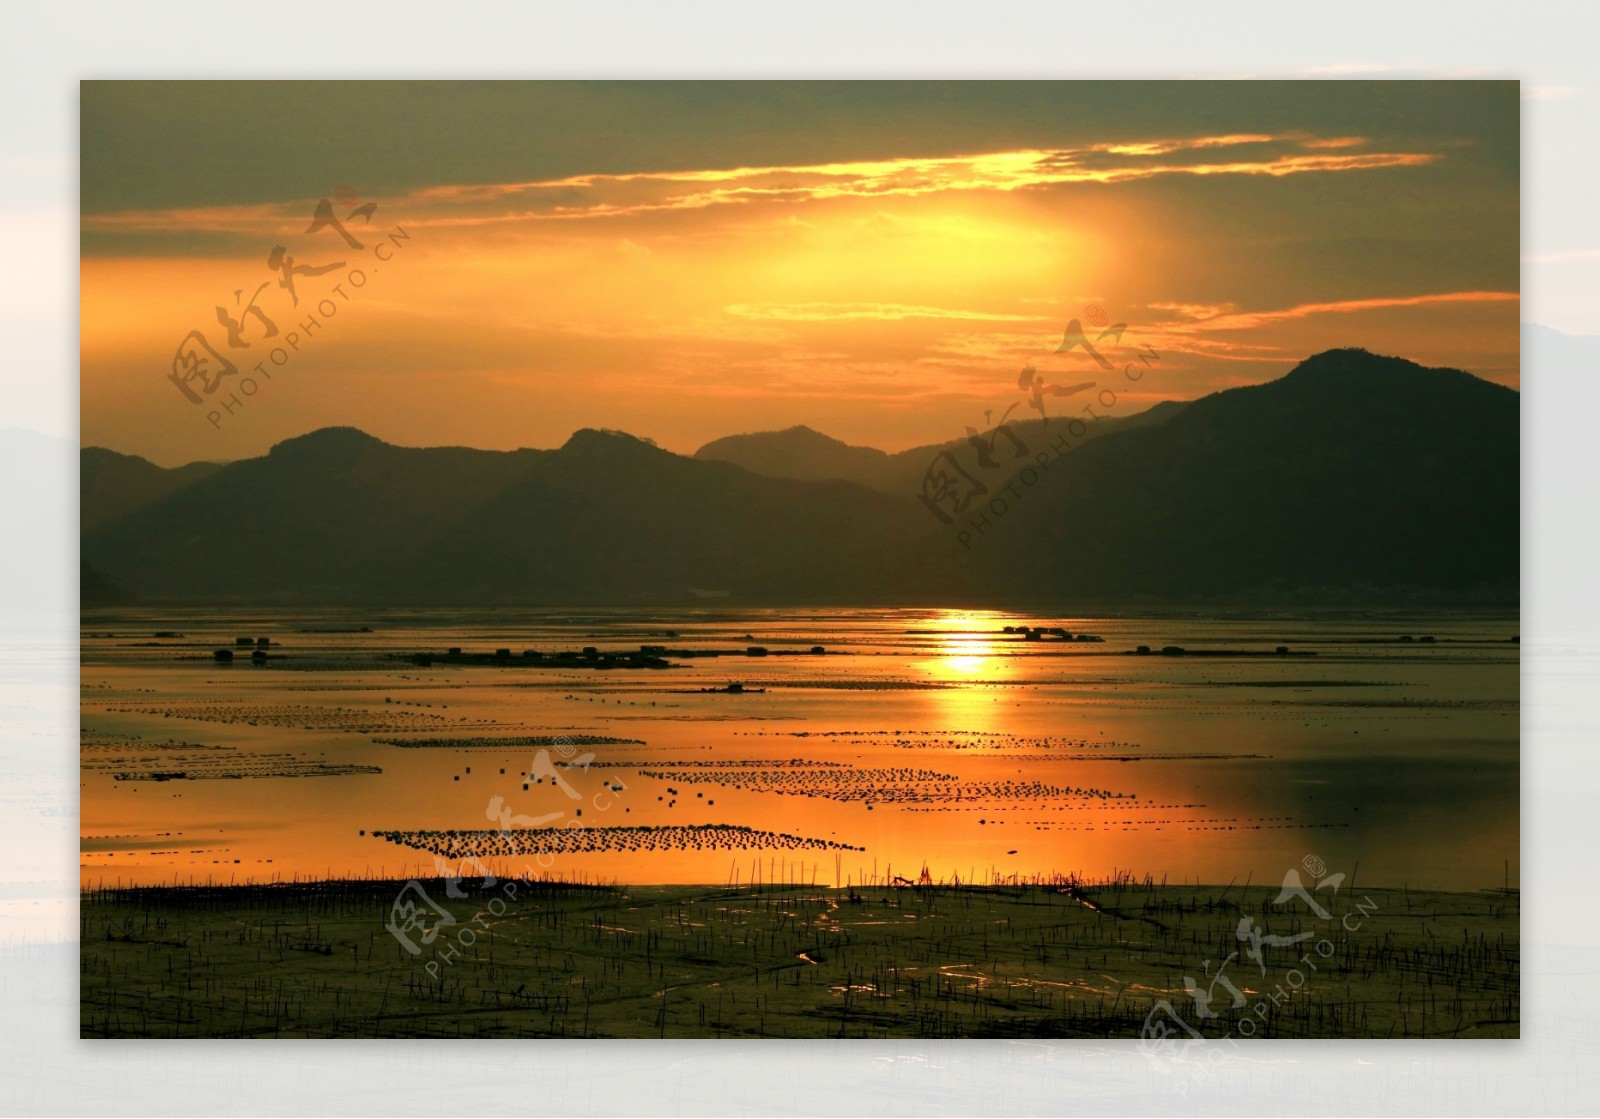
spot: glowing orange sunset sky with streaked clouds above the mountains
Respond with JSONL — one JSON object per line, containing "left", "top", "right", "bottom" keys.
{"left": 82, "top": 83, "right": 1518, "bottom": 464}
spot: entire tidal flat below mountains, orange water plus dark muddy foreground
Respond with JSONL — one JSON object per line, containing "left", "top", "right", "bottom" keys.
{"left": 80, "top": 608, "right": 1520, "bottom": 1044}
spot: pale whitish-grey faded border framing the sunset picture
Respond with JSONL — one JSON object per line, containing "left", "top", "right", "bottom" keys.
{"left": 0, "top": 0, "right": 1600, "bottom": 1116}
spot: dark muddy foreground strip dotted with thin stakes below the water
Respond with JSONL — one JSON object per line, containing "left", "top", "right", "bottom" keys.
{"left": 82, "top": 879, "right": 1520, "bottom": 1047}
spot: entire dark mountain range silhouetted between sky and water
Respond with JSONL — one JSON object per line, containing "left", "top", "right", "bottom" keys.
{"left": 82, "top": 349, "right": 1520, "bottom": 608}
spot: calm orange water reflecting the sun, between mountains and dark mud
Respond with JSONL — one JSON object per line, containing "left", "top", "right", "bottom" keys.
{"left": 82, "top": 610, "right": 1518, "bottom": 888}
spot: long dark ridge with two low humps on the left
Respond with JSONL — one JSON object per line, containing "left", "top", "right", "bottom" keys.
{"left": 83, "top": 429, "right": 926, "bottom": 604}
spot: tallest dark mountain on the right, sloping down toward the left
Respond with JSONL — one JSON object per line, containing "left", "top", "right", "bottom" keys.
{"left": 965, "top": 349, "right": 1520, "bottom": 600}
